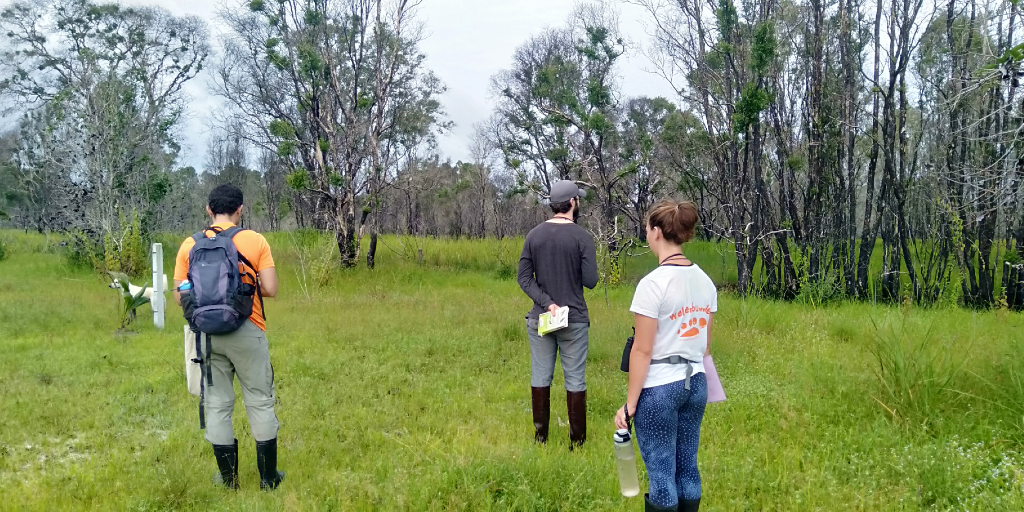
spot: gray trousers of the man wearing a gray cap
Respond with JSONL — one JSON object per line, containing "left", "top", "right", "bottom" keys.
{"left": 526, "top": 319, "right": 590, "bottom": 391}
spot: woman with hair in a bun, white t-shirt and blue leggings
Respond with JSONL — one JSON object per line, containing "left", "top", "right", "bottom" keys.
{"left": 615, "top": 201, "right": 718, "bottom": 512}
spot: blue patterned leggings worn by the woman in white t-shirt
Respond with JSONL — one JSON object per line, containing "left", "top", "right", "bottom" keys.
{"left": 633, "top": 374, "right": 708, "bottom": 508}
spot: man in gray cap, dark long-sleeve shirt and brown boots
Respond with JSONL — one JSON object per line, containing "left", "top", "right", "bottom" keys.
{"left": 519, "top": 180, "right": 598, "bottom": 450}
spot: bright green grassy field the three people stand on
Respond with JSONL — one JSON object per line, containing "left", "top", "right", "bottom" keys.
{"left": 0, "top": 231, "right": 1024, "bottom": 511}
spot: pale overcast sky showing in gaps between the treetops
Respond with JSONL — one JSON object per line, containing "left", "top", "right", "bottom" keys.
{"left": 117, "top": 0, "right": 673, "bottom": 169}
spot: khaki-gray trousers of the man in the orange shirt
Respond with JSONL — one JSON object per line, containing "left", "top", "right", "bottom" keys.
{"left": 203, "top": 322, "right": 280, "bottom": 444}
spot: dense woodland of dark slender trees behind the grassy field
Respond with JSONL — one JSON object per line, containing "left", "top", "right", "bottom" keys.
{"left": 0, "top": 0, "right": 1024, "bottom": 307}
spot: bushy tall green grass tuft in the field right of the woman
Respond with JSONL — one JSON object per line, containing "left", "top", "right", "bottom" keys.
{"left": 870, "top": 316, "right": 968, "bottom": 431}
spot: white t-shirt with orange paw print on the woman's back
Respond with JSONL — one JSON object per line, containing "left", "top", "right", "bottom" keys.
{"left": 630, "top": 264, "right": 718, "bottom": 388}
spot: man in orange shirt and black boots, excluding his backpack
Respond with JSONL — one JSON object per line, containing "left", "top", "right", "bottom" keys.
{"left": 174, "top": 184, "right": 285, "bottom": 489}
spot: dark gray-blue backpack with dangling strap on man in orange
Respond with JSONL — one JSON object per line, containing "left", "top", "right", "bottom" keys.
{"left": 181, "top": 226, "right": 266, "bottom": 428}
